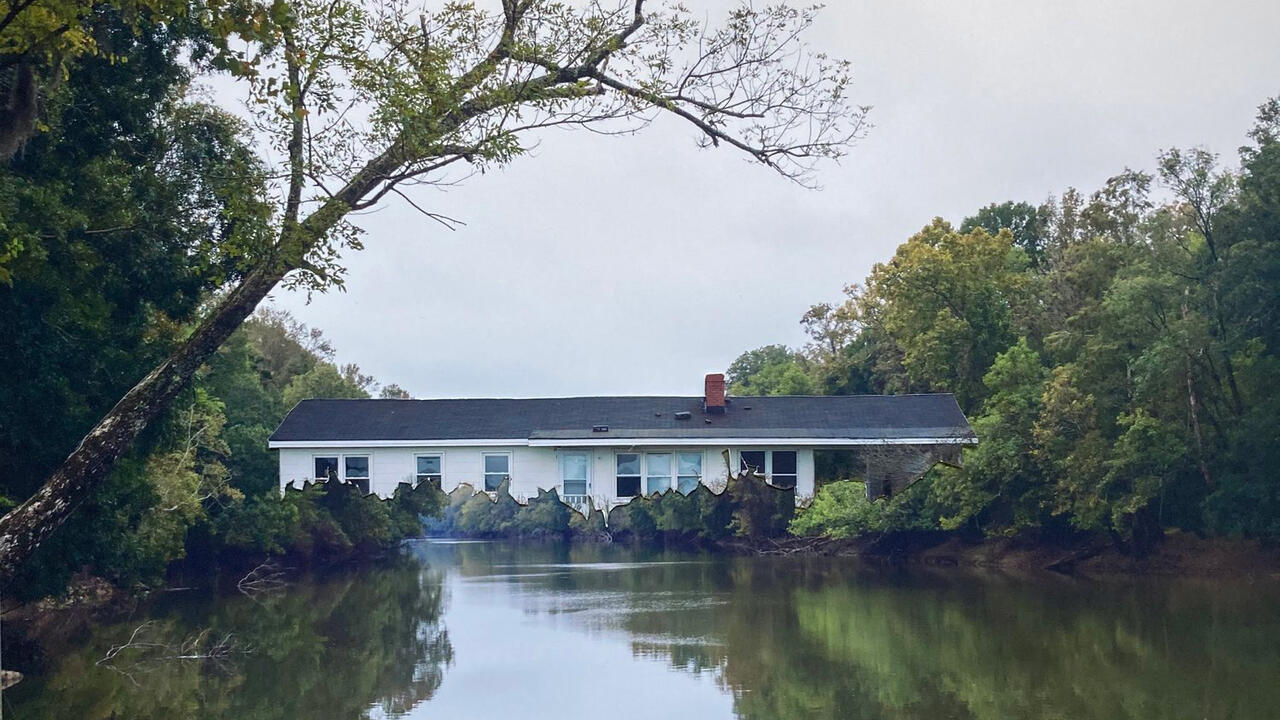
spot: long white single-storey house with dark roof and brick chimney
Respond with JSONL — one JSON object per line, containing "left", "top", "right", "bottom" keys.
{"left": 269, "top": 374, "right": 977, "bottom": 509}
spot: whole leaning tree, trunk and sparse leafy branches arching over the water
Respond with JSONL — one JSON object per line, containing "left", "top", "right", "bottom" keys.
{"left": 0, "top": 0, "right": 867, "bottom": 578}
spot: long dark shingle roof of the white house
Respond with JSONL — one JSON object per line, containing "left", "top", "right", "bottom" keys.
{"left": 270, "top": 395, "right": 975, "bottom": 442}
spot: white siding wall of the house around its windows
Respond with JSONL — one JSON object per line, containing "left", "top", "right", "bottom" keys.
{"left": 278, "top": 446, "right": 814, "bottom": 507}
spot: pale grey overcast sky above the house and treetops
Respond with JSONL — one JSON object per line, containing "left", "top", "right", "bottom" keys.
{"left": 257, "top": 0, "right": 1280, "bottom": 397}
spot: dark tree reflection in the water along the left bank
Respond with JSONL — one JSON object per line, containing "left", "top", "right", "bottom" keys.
{"left": 5, "top": 561, "right": 453, "bottom": 720}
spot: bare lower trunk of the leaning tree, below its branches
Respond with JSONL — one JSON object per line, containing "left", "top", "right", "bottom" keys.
{"left": 0, "top": 268, "right": 284, "bottom": 582}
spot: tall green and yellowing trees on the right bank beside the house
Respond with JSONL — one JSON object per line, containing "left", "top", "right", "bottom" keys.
{"left": 728, "top": 100, "right": 1280, "bottom": 550}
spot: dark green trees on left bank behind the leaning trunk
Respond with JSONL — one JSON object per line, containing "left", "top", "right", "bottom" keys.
{"left": 0, "top": 18, "right": 276, "bottom": 593}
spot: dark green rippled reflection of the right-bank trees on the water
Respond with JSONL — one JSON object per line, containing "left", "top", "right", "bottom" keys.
{"left": 440, "top": 546, "right": 1280, "bottom": 720}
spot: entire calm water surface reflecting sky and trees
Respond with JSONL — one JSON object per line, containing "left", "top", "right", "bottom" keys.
{"left": 3, "top": 542, "right": 1280, "bottom": 720}
